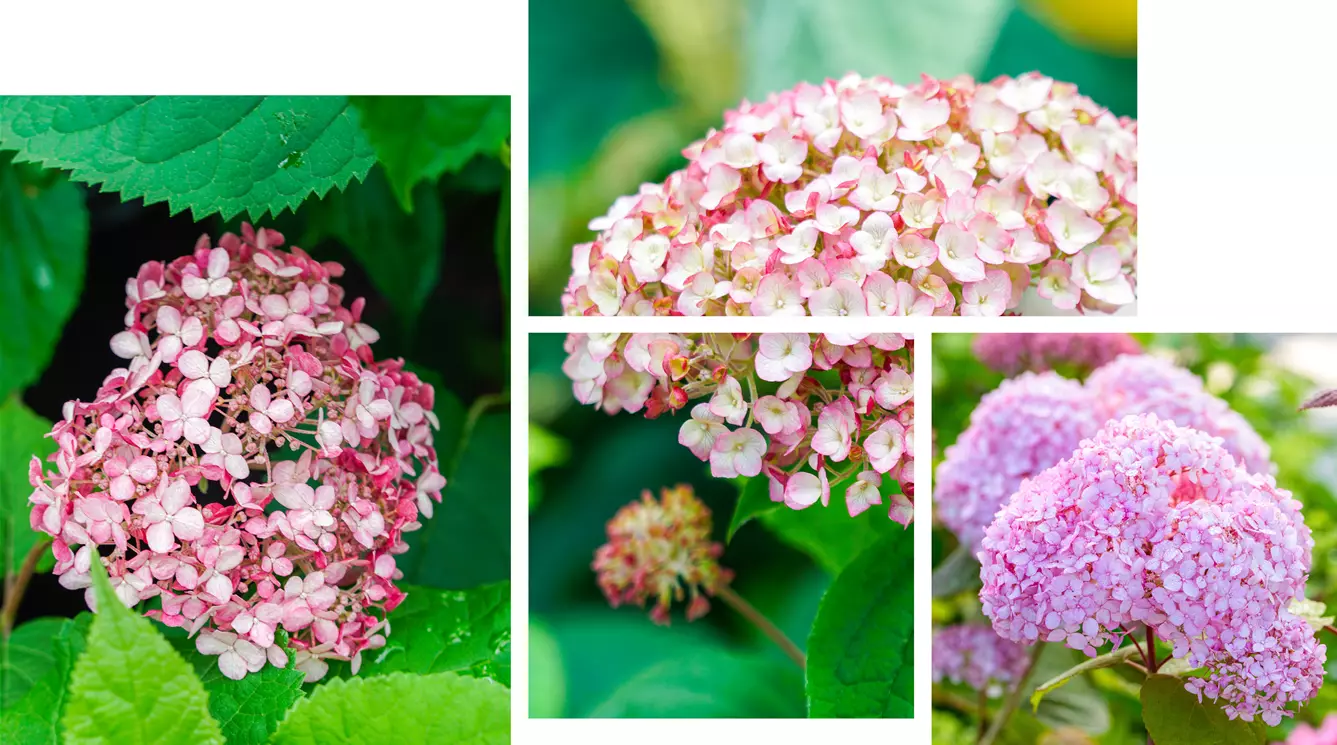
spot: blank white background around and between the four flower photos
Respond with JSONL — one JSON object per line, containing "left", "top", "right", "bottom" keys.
{"left": 0, "top": 0, "right": 1337, "bottom": 745}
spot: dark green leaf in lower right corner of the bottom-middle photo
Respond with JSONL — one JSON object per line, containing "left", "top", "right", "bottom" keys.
{"left": 808, "top": 529, "right": 915, "bottom": 718}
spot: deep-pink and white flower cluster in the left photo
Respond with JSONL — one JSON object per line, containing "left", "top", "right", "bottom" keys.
{"left": 29, "top": 225, "right": 445, "bottom": 681}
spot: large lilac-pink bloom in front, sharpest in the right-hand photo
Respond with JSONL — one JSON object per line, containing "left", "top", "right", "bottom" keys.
{"left": 979, "top": 415, "right": 1326, "bottom": 725}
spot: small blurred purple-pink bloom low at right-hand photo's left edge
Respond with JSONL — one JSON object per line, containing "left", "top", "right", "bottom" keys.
{"left": 933, "top": 623, "right": 1028, "bottom": 696}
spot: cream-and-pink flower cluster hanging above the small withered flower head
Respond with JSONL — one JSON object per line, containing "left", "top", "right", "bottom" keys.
{"left": 563, "top": 333, "right": 915, "bottom": 524}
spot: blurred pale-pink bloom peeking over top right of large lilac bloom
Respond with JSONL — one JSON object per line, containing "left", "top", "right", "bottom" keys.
{"left": 1086, "top": 354, "right": 1273, "bottom": 473}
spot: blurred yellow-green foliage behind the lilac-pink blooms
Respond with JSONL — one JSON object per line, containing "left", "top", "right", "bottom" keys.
{"left": 933, "top": 334, "right": 1337, "bottom": 745}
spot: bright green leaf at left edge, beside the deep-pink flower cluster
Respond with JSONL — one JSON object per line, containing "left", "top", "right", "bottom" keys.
{"left": 0, "top": 398, "right": 56, "bottom": 575}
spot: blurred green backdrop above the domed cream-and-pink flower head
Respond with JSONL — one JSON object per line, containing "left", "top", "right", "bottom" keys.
{"left": 529, "top": 0, "right": 1136, "bottom": 314}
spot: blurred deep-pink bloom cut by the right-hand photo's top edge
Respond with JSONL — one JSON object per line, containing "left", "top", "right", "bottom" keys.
{"left": 972, "top": 333, "right": 1142, "bottom": 376}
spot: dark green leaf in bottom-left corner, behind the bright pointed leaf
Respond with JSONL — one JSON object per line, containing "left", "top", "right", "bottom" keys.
{"left": 0, "top": 613, "right": 92, "bottom": 745}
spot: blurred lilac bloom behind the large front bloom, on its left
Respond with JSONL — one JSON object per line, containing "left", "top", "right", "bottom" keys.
{"left": 933, "top": 372, "right": 1103, "bottom": 552}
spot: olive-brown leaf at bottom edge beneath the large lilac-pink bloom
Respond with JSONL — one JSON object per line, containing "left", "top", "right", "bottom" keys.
{"left": 1142, "top": 675, "right": 1267, "bottom": 745}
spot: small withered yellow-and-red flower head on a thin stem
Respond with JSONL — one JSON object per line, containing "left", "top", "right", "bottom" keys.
{"left": 592, "top": 484, "right": 734, "bottom": 625}
